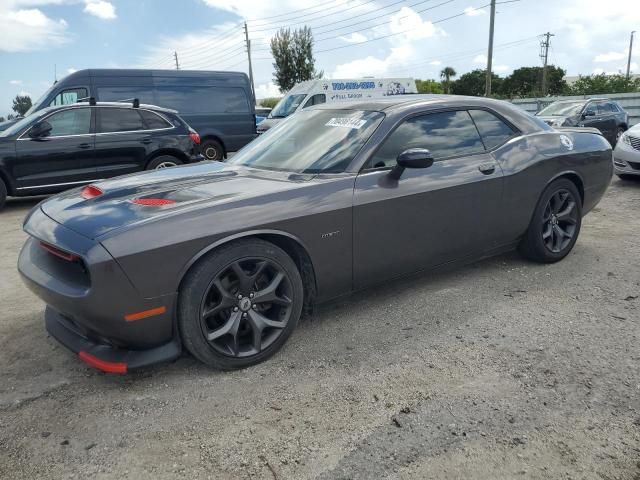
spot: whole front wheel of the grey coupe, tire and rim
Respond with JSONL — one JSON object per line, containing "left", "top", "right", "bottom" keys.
{"left": 178, "top": 239, "right": 304, "bottom": 370}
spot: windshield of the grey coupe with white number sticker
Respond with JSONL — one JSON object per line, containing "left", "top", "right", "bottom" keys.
{"left": 229, "top": 110, "right": 384, "bottom": 173}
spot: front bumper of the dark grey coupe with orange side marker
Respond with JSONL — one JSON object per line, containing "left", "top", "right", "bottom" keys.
{"left": 18, "top": 207, "right": 180, "bottom": 371}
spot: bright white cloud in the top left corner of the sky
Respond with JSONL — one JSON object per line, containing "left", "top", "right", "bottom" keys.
{"left": 0, "top": 6, "right": 68, "bottom": 52}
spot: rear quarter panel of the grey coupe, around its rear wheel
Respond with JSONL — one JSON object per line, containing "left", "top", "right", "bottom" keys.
{"left": 494, "top": 129, "right": 613, "bottom": 243}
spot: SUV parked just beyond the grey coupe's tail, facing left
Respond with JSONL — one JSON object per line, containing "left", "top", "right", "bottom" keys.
{"left": 536, "top": 98, "right": 629, "bottom": 146}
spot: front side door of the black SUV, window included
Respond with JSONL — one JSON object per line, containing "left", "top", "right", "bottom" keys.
{"left": 13, "top": 106, "right": 96, "bottom": 193}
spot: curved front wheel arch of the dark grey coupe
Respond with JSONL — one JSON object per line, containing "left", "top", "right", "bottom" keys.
{"left": 177, "top": 229, "right": 317, "bottom": 315}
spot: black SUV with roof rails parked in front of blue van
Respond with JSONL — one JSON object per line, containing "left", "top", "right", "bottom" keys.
{"left": 0, "top": 100, "right": 204, "bottom": 208}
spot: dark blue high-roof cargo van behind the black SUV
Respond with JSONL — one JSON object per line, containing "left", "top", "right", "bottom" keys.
{"left": 0, "top": 69, "right": 256, "bottom": 160}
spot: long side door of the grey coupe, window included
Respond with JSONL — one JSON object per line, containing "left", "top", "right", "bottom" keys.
{"left": 353, "top": 110, "right": 503, "bottom": 289}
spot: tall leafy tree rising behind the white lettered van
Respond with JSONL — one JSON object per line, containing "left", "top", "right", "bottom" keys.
{"left": 271, "top": 26, "right": 323, "bottom": 93}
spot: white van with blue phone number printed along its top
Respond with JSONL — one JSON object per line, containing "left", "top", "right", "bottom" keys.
{"left": 258, "top": 78, "right": 418, "bottom": 133}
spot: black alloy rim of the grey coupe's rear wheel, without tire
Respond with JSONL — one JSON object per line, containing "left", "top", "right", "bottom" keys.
{"left": 542, "top": 189, "right": 578, "bottom": 253}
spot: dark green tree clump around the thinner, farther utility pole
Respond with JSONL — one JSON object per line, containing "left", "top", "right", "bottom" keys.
{"left": 500, "top": 65, "right": 567, "bottom": 98}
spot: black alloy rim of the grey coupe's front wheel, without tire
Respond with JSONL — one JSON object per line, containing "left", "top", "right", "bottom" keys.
{"left": 200, "top": 257, "right": 293, "bottom": 357}
